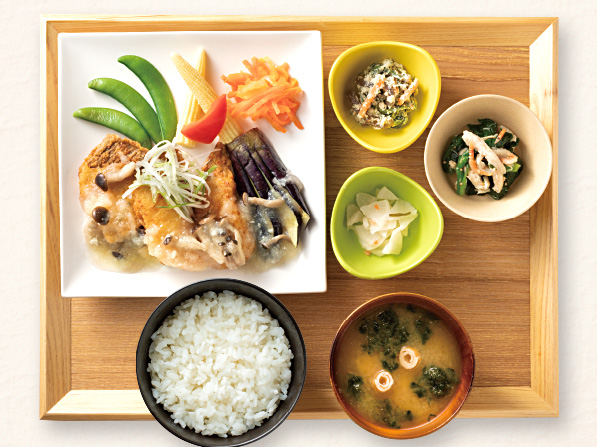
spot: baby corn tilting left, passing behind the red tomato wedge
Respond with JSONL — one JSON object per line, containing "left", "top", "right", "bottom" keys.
{"left": 171, "top": 53, "right": 242, "bottom": 144}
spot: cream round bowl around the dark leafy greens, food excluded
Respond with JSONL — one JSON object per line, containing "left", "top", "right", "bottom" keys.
{"left": 424, "top": 95, "right": 553, "bottom": 222}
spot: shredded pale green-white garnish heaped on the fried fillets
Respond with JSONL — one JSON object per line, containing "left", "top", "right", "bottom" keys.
{"left": 122, "top": 141, "right": 215, "bottom": 222}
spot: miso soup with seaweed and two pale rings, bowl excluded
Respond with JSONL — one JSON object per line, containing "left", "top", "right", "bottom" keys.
{"left": 334, "top": 304, "right": 462, "bottom": 428}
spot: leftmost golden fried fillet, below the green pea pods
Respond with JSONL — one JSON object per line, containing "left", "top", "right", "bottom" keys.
{"left": 79, "top": 134, "right": 147, "bottom": 244}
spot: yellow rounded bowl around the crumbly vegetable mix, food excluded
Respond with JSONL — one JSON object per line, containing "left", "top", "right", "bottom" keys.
{"left": 328, "top": 41, "right": 441, "bottom": 153}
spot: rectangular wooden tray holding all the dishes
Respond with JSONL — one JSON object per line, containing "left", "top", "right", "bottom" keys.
{"left": 40, "top": 16, "right": 558, "bottom": 420}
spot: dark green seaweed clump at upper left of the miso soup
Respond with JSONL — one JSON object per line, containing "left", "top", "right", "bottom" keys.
{"left": 359, "top": 309, "right": 410, "bottom": 372}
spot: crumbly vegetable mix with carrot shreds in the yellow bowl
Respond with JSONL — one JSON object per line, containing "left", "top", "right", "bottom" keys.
{"left": 347, "top": 59, "right": 419, "bottom": 129}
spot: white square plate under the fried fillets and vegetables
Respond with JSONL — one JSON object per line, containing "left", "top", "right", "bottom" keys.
{"left": 58, "top": 31, "right": 326, "bottom": 297}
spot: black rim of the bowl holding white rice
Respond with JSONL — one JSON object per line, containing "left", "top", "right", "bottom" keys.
{"left": 135, "top": 278, "right": 307, "bottom": 447}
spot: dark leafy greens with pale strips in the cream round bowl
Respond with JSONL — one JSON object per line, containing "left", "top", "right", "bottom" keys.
{"left": 442, "top": 118, "right": 523, "bottom": 200}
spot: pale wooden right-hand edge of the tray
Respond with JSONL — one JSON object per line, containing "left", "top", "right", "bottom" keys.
{"left": 530, "top": 20, "right": 559, "bottom": 416}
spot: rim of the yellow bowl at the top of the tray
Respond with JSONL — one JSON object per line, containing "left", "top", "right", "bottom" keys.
{"left": 328, "top": 40, "right": 442, "bottom": 154}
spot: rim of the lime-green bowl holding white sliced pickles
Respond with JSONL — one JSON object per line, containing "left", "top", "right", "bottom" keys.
{"left": 330, "top": 166, "right": 444, "bottom": 280}
